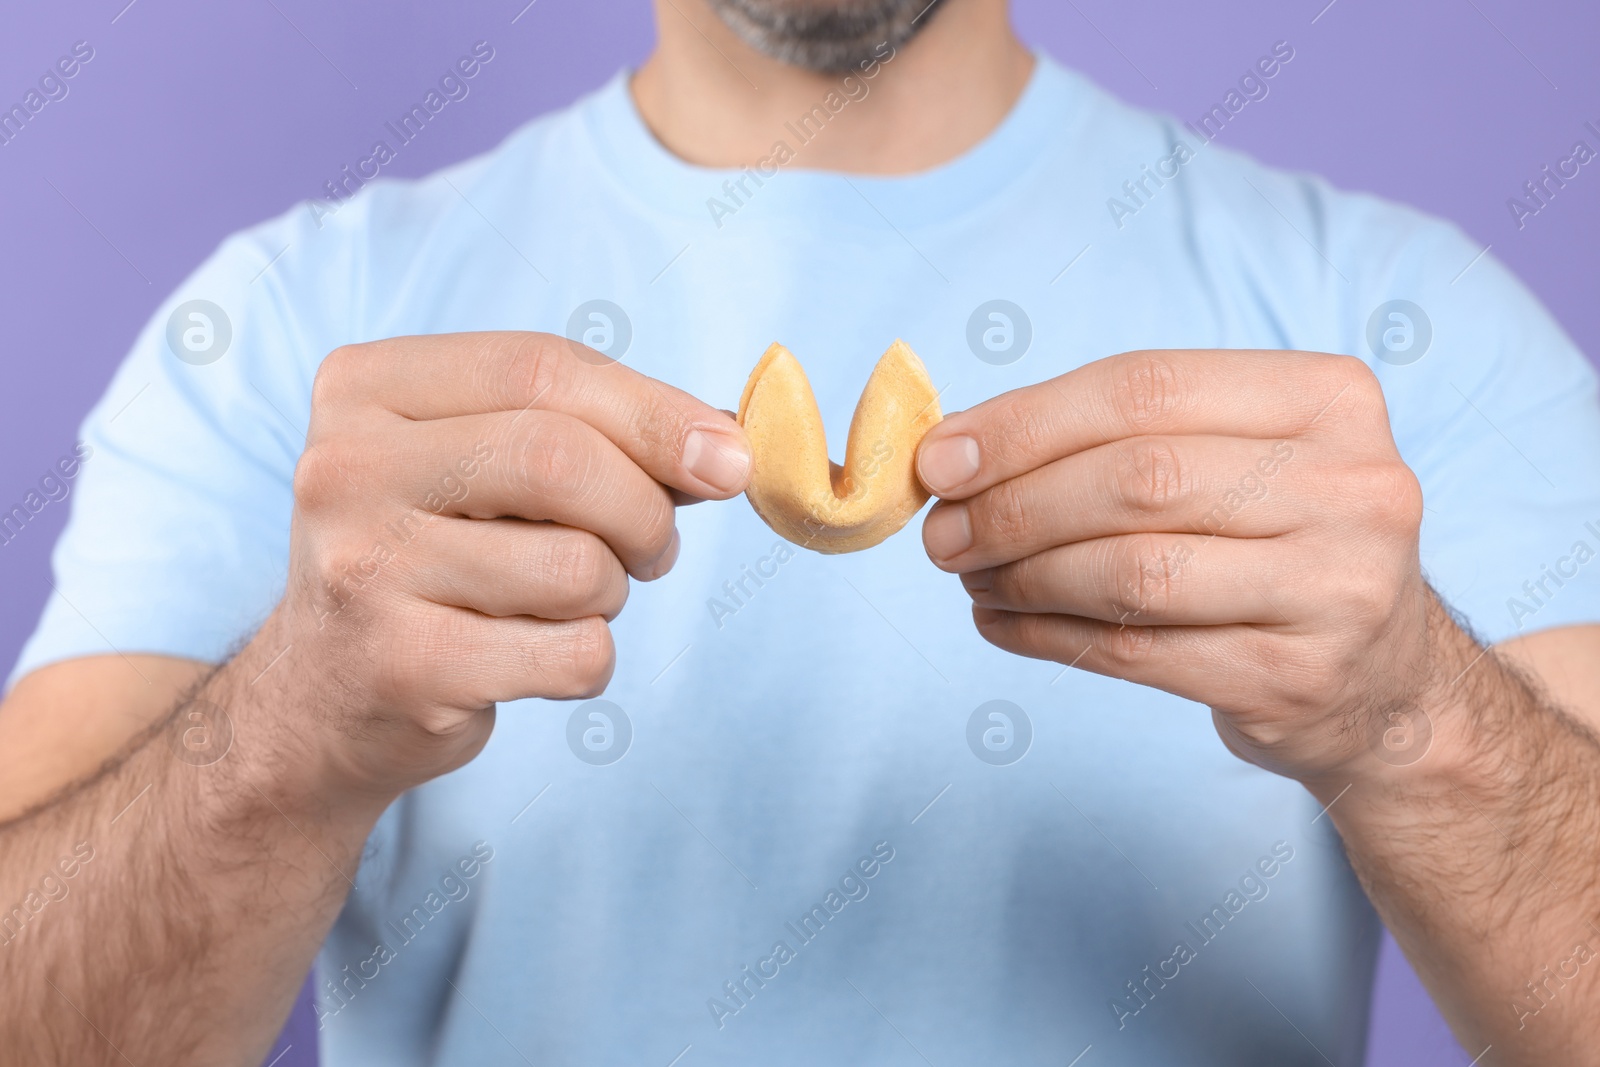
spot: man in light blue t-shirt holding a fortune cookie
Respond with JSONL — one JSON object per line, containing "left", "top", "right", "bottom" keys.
{"left": 0, "top": 0, "right": 1600, "bottom": 1067}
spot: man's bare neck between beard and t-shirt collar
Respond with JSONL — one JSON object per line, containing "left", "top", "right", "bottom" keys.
{"left": 632, "top": 0, "right": 1034, "bottom": 174}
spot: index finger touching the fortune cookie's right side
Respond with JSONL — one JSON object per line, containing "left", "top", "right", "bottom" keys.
{"left": 917, "top": 349, "right": 1370, "bottom": 499}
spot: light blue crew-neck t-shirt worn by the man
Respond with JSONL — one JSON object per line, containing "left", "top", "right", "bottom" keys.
{"left": 16, "top": 59, "right": 1600, "bottom": 1067}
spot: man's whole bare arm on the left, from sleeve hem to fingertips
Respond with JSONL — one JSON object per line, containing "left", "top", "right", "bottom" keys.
{"left": 0, "top": 333, "right": 749, "bottom": 1067}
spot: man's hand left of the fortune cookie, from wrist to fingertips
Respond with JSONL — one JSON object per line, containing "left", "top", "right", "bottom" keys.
{"left": 273, "top": 333, "right": 750, "bottom": 800}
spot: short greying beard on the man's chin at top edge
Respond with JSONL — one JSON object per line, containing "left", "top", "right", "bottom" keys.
{"left": 709, "top": 0, "right": 942, "bottom": 74}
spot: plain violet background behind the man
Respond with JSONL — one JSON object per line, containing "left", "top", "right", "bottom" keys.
{"left": 0, "top": 0, "right": 1600, "bottom": 1067}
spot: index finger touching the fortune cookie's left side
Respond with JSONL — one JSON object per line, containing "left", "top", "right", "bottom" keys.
{"left": 317, "top": 331, "right": 750, "bottom": 499}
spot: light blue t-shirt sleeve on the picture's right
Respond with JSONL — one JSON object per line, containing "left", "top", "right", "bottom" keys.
{"left": 1352, "top": 216, "right": 1600, "bottom": 643}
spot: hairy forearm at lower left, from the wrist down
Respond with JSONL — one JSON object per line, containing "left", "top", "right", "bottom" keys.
{"left": 0, "top": 627, "right": 378, "bottom": 1067}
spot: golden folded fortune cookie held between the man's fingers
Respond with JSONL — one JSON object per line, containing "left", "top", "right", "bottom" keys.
{"left": 739, "top": 341, "right": 944, "bottom": 552}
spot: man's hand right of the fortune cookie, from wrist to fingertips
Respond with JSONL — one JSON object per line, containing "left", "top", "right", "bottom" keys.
{"left": 917, "top": 350, "right": 1453, "bottom": 779}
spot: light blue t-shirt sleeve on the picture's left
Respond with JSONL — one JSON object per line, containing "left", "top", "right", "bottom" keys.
{"left": 6, "top": 206, "right": 352, "bottom": 688}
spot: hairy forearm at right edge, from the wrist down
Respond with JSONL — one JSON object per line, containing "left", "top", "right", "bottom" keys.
{"left": 1312, "top": 613, "right": 1600, "bottom": 1064}
